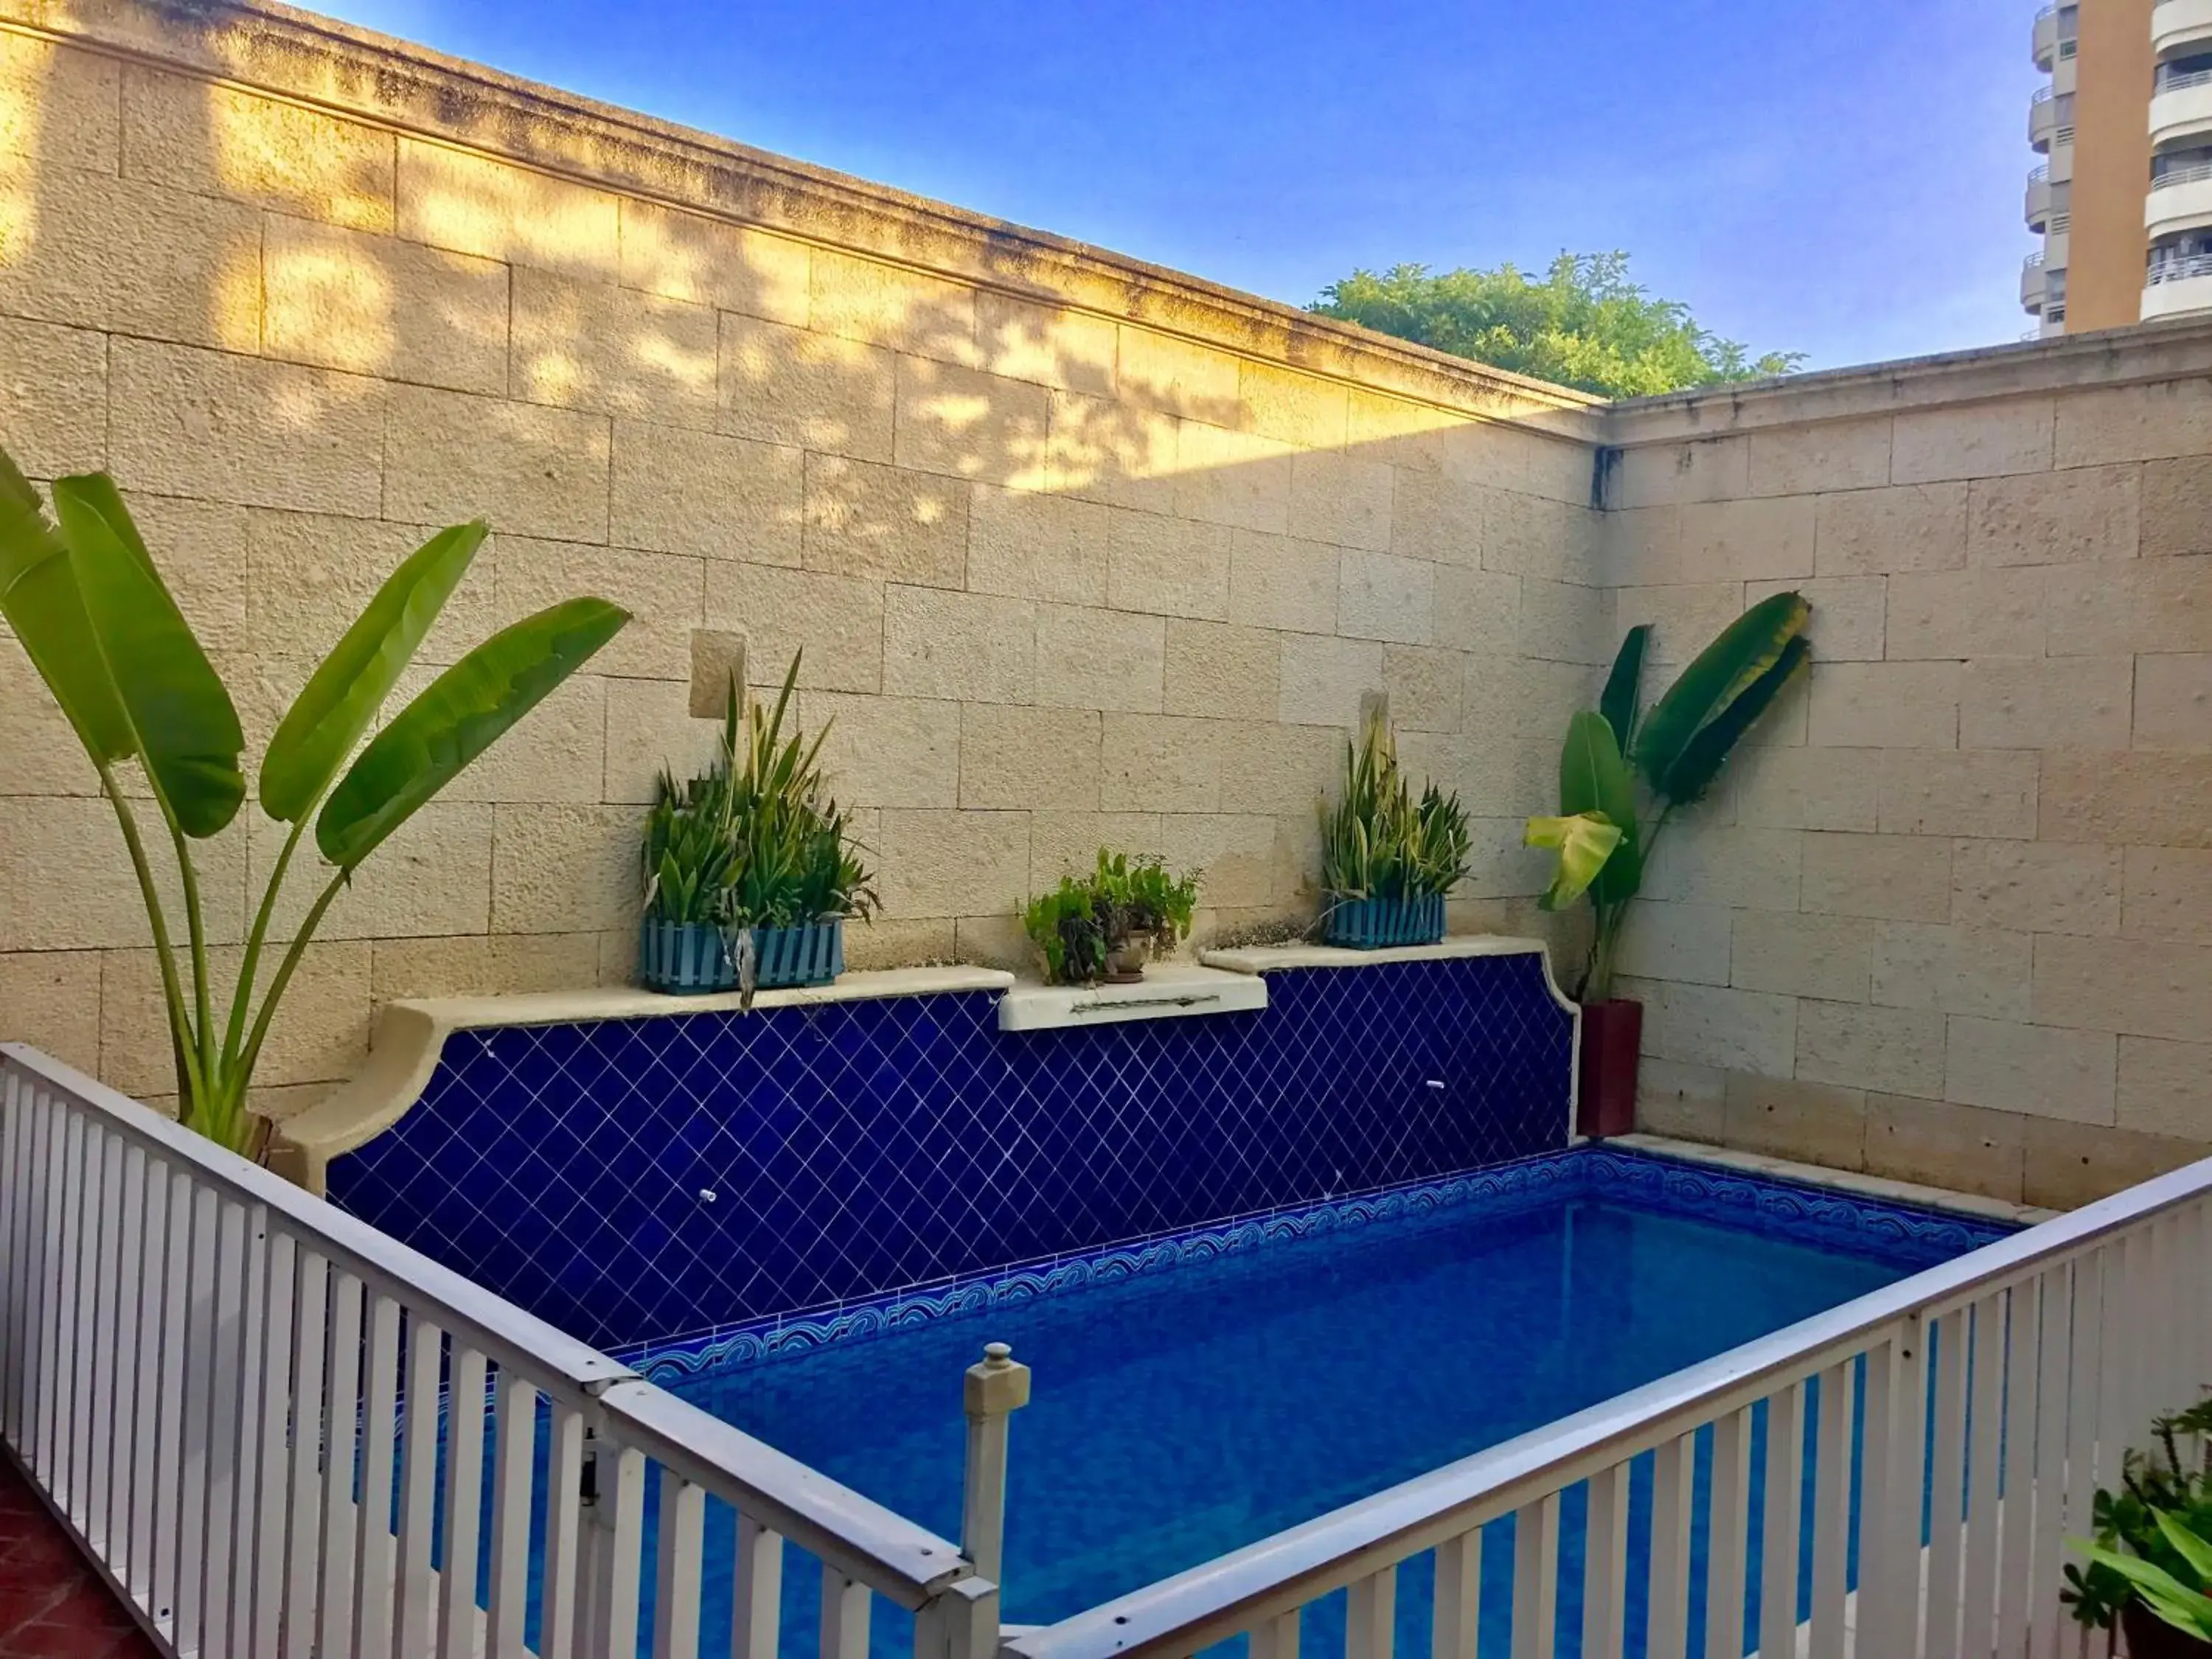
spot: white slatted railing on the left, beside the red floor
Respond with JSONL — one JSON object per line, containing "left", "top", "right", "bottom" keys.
{"left": 0, "top": 1044, "right": 1004, "bottom": 1659}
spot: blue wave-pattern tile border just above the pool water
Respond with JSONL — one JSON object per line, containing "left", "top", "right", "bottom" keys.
{"left": 617, "top": 1146, "right": 2013, "bottom": 1382}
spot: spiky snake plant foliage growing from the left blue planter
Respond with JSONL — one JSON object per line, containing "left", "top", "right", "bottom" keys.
{"left": 641, "top": 655, "right": 878, "bottom": 933}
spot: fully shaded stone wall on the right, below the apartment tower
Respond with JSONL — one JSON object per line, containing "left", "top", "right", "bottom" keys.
{"left": 1606, "top": 327, "right": 2212, "bottom": 1203}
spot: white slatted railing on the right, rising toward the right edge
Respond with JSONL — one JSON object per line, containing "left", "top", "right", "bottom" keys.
{"left": 1004, "top": 1161, "right": 2212, "bottom": 1659}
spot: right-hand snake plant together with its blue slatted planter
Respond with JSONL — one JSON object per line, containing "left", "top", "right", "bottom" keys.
{"left": 1321, "top": 710, "right": 1469, "bottom": 951}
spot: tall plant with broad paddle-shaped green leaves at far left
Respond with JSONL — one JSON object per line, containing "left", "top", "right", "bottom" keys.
{"left": 0, "top": 451, "right": 628, "bottom": 1155}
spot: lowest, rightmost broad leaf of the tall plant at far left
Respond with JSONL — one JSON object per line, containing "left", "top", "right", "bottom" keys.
{"left": 314, "top": 599, "right": 630, "bottom": 869}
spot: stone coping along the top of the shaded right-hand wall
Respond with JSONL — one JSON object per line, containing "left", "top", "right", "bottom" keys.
{"left": 1606, "top": 319, "right": 2212, "bottom": 449}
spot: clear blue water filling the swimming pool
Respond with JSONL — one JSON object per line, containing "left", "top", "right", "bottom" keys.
{"left": 650, "top": 1168, "right": 1991, "bottom": 1650}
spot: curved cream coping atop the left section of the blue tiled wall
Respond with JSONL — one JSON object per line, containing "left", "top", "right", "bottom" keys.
{"left": 270, "top": 967, "right": 1013, "bottom": 1197}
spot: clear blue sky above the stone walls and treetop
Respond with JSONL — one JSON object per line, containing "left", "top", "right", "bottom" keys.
{"left": 327, "top": 0, "right": 2037, "bottom": 367}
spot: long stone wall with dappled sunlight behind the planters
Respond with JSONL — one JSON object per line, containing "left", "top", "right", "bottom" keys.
{"left": 0, "top": 0, "right": 1610, "bottom": 1110}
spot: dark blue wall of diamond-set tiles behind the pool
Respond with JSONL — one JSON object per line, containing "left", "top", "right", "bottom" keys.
{"left": 330, "top": 953, "right": 1573, "bottom": 1347}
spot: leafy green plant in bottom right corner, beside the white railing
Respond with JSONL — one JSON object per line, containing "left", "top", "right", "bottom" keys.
{"left": 2062, "top": 1398, "right": 2212, "bottom": 1659}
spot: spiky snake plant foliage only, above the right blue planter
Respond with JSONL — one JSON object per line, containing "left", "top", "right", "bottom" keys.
{"left": 1321, "top": 710, "right": 1471, "bottom": 905}
